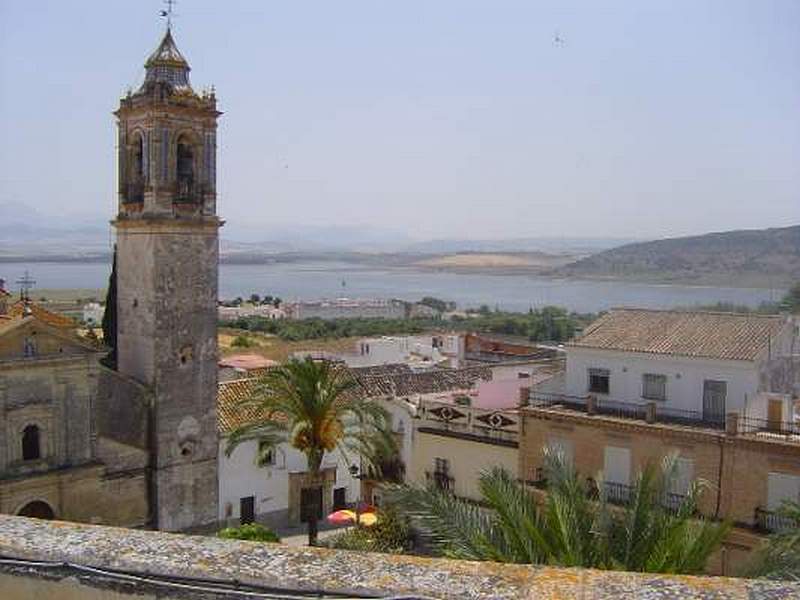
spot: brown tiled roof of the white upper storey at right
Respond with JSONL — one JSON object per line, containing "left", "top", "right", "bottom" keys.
{"left": 568, "top": 308, "right": 787, "bottom": 361}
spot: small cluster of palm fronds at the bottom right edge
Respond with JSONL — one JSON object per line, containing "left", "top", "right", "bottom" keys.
{"left": 748, "top": 501, "right": 800, "bottom": 581}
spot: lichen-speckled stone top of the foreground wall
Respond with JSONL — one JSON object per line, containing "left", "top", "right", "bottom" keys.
{"left": 0, "top": 516, "right": 800, "bottom": 600}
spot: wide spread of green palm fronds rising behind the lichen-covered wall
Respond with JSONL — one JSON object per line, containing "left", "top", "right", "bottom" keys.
{"left": 389, "top": 449, "right": 729, "bottom": 573}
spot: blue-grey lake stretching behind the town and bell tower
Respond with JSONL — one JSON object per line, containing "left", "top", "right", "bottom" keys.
{"left": 0, "top": 262, "right": 783, "bottom": 312}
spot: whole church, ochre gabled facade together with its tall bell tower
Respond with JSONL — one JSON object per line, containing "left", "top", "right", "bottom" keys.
{"left": 0, "top": 27, "right": 222, "bottom": 531}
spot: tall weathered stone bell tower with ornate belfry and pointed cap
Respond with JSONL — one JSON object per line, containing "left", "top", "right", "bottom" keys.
{"left": 113, "top": 27, "right": 222, "bottom": 531}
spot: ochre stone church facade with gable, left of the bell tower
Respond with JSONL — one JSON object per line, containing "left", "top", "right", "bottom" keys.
{"left": 0, "top": 307, "right": 148, "bottom": 527}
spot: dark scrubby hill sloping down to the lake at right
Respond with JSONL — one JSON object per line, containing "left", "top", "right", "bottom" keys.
{"left": 549, "top": 225, "right": 800, "bottom": 287}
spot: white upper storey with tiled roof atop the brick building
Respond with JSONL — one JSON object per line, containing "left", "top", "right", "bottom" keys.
{"left": 552, "top": 309, "right": 797, "bottom": 423}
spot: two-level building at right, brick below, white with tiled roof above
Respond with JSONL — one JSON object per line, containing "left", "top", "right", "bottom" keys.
{"left": 519, "top": 309, "right": 800, "bottom": 574}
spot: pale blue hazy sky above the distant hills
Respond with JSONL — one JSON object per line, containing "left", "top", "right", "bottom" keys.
{"left": 0, "top": 0, "right": 800, "bottom": 238}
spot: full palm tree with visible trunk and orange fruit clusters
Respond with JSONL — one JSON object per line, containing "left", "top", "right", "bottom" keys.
{"left": 225, "top": 357, "right": 394, "bottom": 546}
